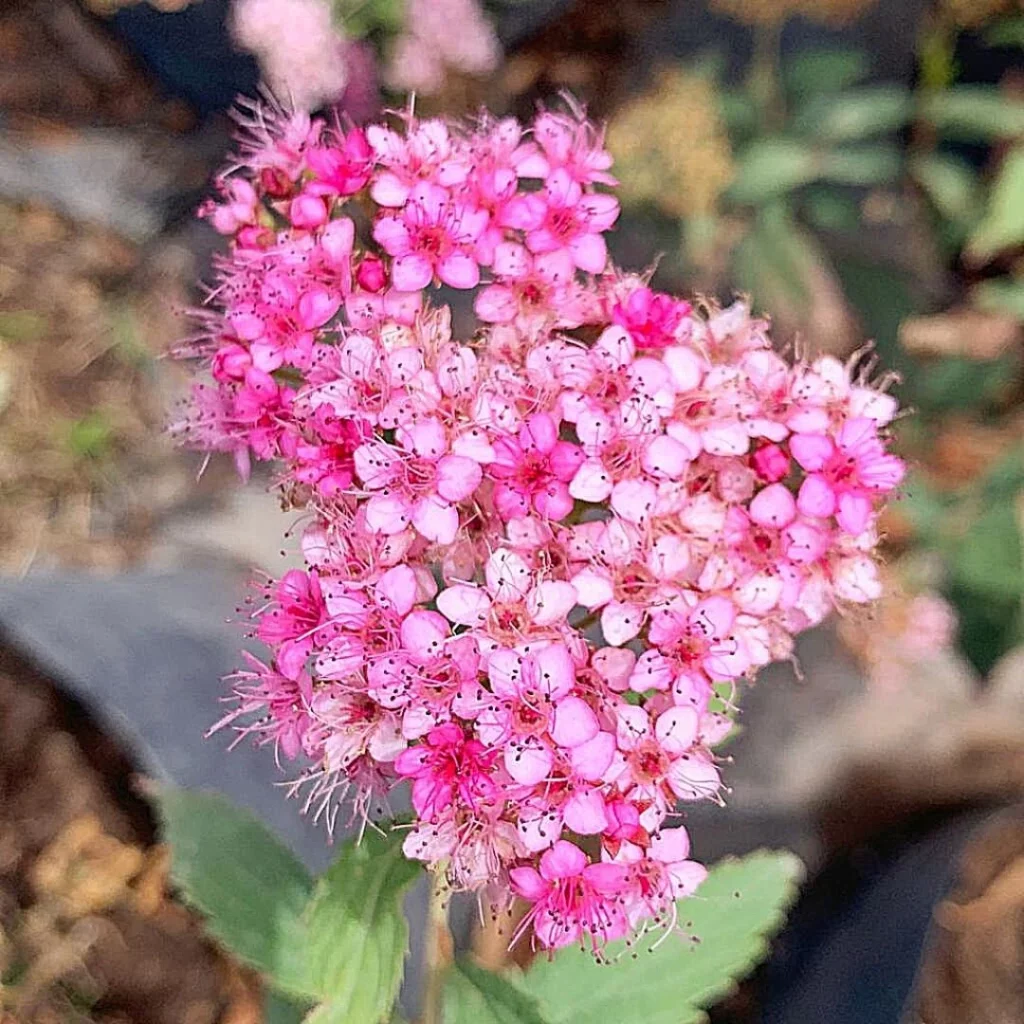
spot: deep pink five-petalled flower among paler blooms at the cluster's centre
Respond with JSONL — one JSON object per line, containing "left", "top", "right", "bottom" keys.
{"left": 487, "top": 413, "right": 584, "bottom": 520}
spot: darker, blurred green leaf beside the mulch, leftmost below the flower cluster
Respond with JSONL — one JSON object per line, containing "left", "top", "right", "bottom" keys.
{"left": 154, "top": 785, "right": 314, "bottom": 997}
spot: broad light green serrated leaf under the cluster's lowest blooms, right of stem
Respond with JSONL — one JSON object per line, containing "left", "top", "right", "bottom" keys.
{"left": 523, "top": 850, "right": 803, "bottom": 1024}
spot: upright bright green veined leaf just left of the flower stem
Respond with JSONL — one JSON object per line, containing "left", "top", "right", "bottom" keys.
{"left": 307, "top": 830, "right": 422, "bottom": 1024}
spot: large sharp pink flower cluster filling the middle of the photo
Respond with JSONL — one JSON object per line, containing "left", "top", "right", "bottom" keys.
{"left": 181, "top": 101, "right": 903, "bottom": 947}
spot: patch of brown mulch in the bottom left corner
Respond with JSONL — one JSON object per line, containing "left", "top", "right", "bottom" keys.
{"left": 0, "top": 639, "right": 262, "bottom": 1024}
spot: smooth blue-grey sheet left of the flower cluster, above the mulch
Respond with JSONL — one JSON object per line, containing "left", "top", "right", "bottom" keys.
{"left": 0, "top": 570, "right": 331, "bottom": 870}
